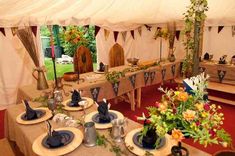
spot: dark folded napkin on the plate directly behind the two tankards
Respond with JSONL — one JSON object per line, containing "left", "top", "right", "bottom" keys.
{"left": 98, "top": 101, "right": 111, "bottom": 123}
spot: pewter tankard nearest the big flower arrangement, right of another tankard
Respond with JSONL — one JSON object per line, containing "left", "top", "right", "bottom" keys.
{"left": 111, "top": 119, "right": 127, "bottom": 142}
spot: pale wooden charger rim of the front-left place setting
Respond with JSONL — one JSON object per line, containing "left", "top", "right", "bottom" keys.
{"left": 32, "top": 127, "right": 83, "bottom": 156}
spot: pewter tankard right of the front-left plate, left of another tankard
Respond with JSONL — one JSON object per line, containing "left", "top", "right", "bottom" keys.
{"left": 84, "top": 122, "right": 97, "bottom": 147}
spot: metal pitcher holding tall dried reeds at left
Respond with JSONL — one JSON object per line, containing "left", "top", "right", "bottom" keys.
{"left": 32, "top": 67, "right": 48, "bottom": 90}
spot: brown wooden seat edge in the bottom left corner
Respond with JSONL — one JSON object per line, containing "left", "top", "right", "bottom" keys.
{"left": 0, "top": 138, "right": 15, "bottom": 156}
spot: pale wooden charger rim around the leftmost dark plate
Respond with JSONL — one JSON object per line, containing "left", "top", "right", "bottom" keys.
{"left": 16, "top": 107, "right": 52, "bottom": 125}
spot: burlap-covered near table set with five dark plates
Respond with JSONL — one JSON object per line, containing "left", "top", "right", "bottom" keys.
{"left": 5, "top": 102, "right": 209, "bottom": 156}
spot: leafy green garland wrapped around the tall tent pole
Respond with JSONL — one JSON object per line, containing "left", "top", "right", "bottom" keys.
{"left": 182, "top": 0, "right": 208, "bottom": 75}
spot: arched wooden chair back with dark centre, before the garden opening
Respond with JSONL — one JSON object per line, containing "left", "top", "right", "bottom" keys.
{"left": 73, "top": 46, "right": 93, "bottom": 74}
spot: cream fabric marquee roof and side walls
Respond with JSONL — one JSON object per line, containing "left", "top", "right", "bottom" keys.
{"left": 0, "top": 0, "right": 235, "bottom": 106}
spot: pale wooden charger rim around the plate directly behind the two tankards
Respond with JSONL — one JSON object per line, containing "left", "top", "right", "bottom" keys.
{"left": 85, "top": 110, "right": 124, "bottom": 129}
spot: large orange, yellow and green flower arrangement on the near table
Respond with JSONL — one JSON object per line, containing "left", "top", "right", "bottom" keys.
{"left": 138, "top": 74, "right": 231, "bottom": 150}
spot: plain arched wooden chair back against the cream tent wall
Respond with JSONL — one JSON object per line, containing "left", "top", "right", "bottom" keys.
{"left": 109, "top": 43, "right": 124, "bottom": 67}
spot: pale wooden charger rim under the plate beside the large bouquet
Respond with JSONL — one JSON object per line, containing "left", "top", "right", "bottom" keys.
{"left": 125, "top": 128, "right": 177, "bottom": 156}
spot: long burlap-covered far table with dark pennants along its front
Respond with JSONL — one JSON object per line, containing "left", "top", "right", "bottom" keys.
{"left": 17, "top": 60, "right": 180, "bottom": 110}
